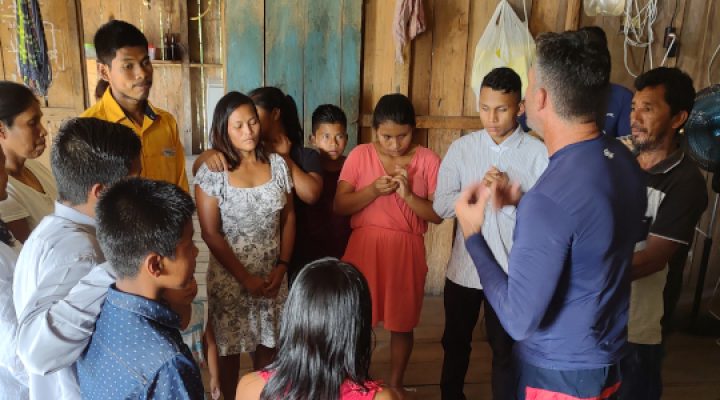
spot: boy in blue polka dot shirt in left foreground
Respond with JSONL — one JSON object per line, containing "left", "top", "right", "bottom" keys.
{"left": 77, "top": 178, "right": 204, "bottom": 399}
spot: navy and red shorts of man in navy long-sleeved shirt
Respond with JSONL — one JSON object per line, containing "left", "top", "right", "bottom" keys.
{"left": 508, "top": 360, "right": 624, "bottom": 400}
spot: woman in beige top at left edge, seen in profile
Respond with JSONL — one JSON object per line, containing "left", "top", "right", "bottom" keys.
{"left": 0, "top": 81, "right": 57, "bottom": 243}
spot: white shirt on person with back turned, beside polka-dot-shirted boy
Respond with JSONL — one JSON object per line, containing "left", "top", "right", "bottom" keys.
{"left": 13, "top": 203, "right": 114, "bottom": 400}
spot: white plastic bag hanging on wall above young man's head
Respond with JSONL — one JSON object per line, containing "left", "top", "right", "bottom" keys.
{"left": 470, "top": 0, "right": 535, "bottom": 110}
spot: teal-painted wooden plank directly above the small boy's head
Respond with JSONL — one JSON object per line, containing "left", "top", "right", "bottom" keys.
{"left": 303, "top": 0, "right": 342, "bottom": 143}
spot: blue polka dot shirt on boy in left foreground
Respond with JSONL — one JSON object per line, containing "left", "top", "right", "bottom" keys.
{"left": 77, "top": 286, "right": 204, "bottom": 400}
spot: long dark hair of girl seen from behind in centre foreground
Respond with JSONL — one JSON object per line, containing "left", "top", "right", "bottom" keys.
{"left": 260, "top": 258, "right": 372, "bottom": 400}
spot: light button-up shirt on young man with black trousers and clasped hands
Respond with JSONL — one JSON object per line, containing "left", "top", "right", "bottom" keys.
{"left": 433, "top": 126, "right": 548, "bottom": 289}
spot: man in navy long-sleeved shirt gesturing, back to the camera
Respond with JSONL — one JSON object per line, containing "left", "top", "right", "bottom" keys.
{"left": 456, "top": 31, "right": 647, "bottom": 399}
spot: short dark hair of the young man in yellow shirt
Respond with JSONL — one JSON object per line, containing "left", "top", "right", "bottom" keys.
{"left": 94, "top": 19, "right": 148, "bottom": 65}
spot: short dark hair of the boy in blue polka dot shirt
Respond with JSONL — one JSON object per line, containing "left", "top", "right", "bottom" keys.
{"left": 96, "top": 178, "right": 195, "bottom": 279}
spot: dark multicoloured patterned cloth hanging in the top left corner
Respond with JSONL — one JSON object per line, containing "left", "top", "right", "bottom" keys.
{"left": 15, "top": 0, "right": 52, "bottom": 105}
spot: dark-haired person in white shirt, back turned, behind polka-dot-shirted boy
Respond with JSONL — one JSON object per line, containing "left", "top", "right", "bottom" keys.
{"left": 13, "top": 118, "right": 141, "bottom": 400}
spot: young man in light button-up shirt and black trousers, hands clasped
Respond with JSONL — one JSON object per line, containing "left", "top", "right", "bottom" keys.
{"left": 433, "top": 68, "right": 548, "bottom": 400}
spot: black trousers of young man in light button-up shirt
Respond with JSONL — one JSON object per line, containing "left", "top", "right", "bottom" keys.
{"left": 440, "top": 279, "right": 514, "bottom": 400}
